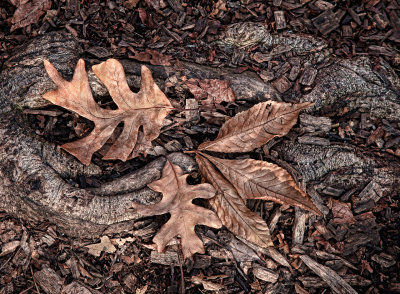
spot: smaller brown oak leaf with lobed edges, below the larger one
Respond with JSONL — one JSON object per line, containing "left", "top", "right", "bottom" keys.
{"left": 132, "top": 160, "right": 222, "bottom": 258}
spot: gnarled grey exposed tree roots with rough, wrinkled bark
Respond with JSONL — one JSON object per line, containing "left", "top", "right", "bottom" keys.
{"left": 0, "top": 32, "right": 400, "bottom": 237}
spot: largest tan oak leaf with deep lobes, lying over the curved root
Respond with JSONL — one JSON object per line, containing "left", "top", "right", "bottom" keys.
{"left": 43, "top": 59, "right": 172, "bottom": 165}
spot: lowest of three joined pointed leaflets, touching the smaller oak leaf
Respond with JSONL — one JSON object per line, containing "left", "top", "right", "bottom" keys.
{"left": 196, "top": 154, "right": 273, "bottom": 247}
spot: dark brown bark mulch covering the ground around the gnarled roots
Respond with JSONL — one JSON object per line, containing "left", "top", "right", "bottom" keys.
{"left": 0, "top": 0, "right": 400, "bottom": 294}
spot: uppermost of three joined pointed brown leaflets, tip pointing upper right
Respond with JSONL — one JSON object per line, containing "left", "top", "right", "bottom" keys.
{"left": 198, "top": 101, "right": 311, "bottom": 152}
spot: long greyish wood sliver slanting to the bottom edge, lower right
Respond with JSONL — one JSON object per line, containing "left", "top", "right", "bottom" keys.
{"left": 300, "top": 255, "right": 357, "bottom": 294}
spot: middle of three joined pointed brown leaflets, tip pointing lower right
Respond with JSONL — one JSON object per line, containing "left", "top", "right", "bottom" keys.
{"left": 200, "top": 153, "right": 322, "bottom": 215}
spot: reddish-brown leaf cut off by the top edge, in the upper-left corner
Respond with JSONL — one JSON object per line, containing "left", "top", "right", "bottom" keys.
{"left": 10, "top": 0, "right": 51, "bottom": 32}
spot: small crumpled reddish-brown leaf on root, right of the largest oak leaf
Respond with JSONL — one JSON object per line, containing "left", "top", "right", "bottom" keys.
{"left": 186, "top": 79, "right": 235, "bottom": 105}
